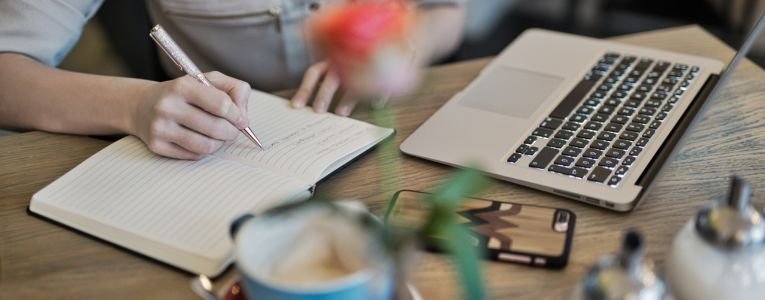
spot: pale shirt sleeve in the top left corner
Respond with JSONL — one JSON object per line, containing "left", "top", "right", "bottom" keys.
{"left": 0, "top": 0, "right": 103, "bottom": 66}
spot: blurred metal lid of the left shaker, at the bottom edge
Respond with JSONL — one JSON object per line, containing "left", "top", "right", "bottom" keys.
{"left": 584, "top": 230, "right": 667, "bottom": 300}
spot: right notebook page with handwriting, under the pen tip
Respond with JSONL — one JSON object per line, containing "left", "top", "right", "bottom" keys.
{"left": 216, "top": 91, "right": 393, "bottom": 182}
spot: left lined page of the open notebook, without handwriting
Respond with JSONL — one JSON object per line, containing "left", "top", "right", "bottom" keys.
{"left": 30, "top": 137, "right": 309, "bottom": 270}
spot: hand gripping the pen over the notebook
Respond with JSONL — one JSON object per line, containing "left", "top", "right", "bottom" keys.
{"left": 130, "top": 72, "right": 250, "bottom": 160}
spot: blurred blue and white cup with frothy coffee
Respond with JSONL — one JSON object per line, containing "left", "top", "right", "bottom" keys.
{"left": 231, "top": 202, "right": 394, "bottom": 300}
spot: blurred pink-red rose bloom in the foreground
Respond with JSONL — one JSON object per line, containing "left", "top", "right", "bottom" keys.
{"left": 309, "top": 0, "right": 418, "bottom": 98}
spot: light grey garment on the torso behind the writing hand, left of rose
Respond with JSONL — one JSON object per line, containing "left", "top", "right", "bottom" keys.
{"left": 147, "top": 0, "right": 343, "bottom": 91}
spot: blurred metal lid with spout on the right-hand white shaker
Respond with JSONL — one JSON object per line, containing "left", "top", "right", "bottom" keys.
{"left": 696, "top": 176, "right": 765, "bottom": 250}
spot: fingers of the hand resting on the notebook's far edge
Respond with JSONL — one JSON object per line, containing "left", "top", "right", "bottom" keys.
{"left": 292, "top": 61, "right": 358, "bottom": 116}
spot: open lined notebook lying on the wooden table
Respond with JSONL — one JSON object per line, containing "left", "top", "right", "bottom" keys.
{"left": 29, "top": 91, "right": 393, "bottom": 276}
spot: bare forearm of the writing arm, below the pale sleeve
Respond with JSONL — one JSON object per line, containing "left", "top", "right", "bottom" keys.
{"left": 0, "top": 53, "right": 155, "bottom": 135}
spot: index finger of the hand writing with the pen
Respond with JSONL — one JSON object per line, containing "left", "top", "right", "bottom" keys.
{"left": 171, "top": 76, "right": 249, "bottom": 129}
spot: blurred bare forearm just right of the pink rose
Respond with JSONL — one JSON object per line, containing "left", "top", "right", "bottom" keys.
{"left": 412, "top": 4, "right": 465, "bottom": 64}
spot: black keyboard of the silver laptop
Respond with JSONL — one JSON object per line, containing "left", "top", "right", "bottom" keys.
{"left": 507, "top": 53, "right": 699, "bottom": 187}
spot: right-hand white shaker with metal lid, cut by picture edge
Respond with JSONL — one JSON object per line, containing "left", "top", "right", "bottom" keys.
{"left": 665, "top": 176, "right": 765, "bottom": 300}
